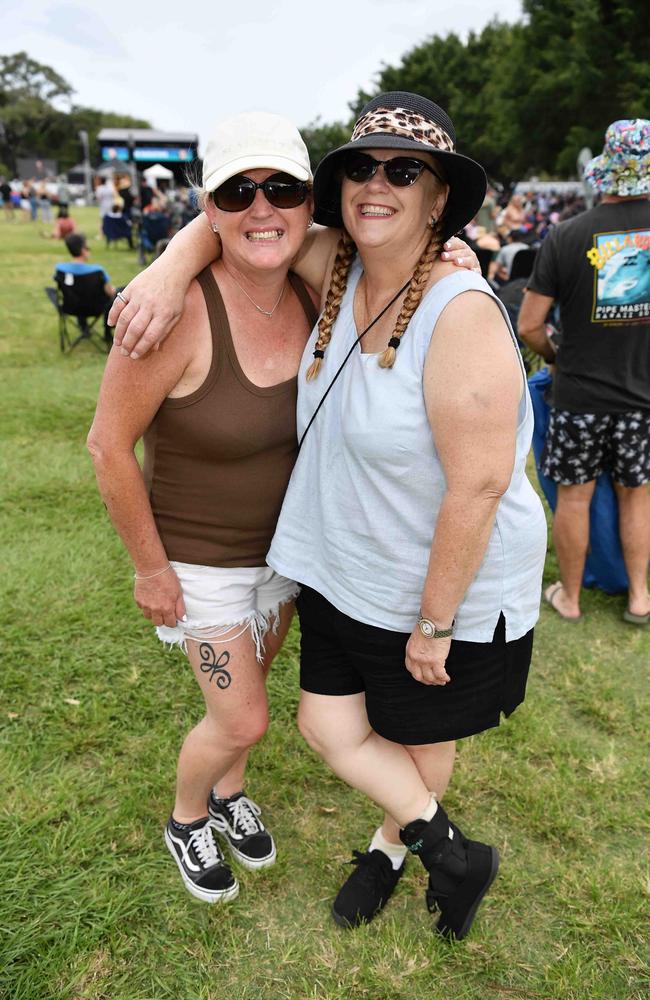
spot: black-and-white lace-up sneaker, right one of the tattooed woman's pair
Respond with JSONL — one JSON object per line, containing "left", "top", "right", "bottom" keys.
{"left": 208, "top": 792, "right": 275, "bottom": 869}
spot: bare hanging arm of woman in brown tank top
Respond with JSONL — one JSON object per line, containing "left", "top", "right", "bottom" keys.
{"left": 87, "top": 302, "right": 199, "bottom": 627}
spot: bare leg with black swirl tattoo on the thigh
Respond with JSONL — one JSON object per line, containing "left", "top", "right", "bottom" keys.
{"left": 173, "top": 631, "right": 268, "bottom": 823}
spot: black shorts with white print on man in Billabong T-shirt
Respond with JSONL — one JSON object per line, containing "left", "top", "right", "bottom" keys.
{"left": 541, "top": 408, "right": 650, "bottom": 486}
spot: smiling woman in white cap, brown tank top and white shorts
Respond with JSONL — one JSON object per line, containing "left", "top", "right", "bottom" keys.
{"left": 88, "top": 113, "right": 316, "bottom": 902}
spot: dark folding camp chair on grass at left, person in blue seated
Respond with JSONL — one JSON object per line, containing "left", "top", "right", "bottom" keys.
{"left": 45, "top": 271, "right": 112, "bottom": 354}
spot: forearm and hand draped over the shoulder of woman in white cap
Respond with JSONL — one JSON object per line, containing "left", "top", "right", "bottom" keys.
{"left": 108, "top": 212, "right": 214, "bottom": 358}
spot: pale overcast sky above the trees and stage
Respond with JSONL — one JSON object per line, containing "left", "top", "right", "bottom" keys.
{"left": 0, "top": 0, "right": 521, "bottom": 154}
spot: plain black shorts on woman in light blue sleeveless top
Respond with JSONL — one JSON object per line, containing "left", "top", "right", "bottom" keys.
{"left": 296, "top": 587, "right": 533, "bottom": 745}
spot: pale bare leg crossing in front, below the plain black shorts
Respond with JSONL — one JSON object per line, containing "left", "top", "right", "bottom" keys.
{"left": 298, "top": 691, "right": 431, "bottom": 826}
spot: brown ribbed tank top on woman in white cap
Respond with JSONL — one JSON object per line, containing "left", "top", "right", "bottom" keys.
{"left": 144, "top": 268, "right": 317, "bottom": 566}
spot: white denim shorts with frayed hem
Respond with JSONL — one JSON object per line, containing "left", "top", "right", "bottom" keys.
{"left": 156, "top": 561, "right": 300, "bottom": 662}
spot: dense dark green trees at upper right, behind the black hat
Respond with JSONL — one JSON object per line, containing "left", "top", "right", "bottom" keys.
{"left": 301, "top": 0, "right": 650, "bottom": 183}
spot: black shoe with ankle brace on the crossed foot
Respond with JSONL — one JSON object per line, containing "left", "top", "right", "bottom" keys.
{"left": 400, "top": 806, "right": 499, "bottom": 941}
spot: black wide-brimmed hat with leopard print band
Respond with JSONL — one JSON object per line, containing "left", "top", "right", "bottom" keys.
{"left": 314, "top": 90, "right": 487, "bottom": 240}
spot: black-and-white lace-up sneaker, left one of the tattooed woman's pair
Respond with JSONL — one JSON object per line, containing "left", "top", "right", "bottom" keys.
{"left": 165, "top": 816, "right": 239, "bottom": 903}
